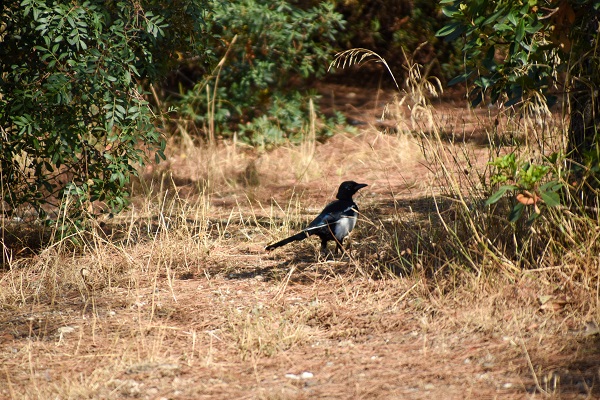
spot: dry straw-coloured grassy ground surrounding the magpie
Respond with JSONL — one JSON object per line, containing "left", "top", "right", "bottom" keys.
{"left": 0, "top": 72, "right": 600, "bottom": 399}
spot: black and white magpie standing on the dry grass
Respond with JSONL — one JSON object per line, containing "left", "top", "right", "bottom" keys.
{"left": 265, "top": 181, "right": 368, "bottom": 252}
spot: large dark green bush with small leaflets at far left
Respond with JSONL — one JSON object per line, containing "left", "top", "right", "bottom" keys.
{"left": 0, "top": 0, "right": 207, "bottom": 225}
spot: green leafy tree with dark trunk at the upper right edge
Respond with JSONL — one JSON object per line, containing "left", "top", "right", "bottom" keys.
{"left": 437, "top": 0, "right": 600, "bottom": 194}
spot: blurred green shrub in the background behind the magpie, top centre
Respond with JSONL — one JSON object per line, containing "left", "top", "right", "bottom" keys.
{"left": 178, "top": 0, "right": 344, "bottom": 145}
